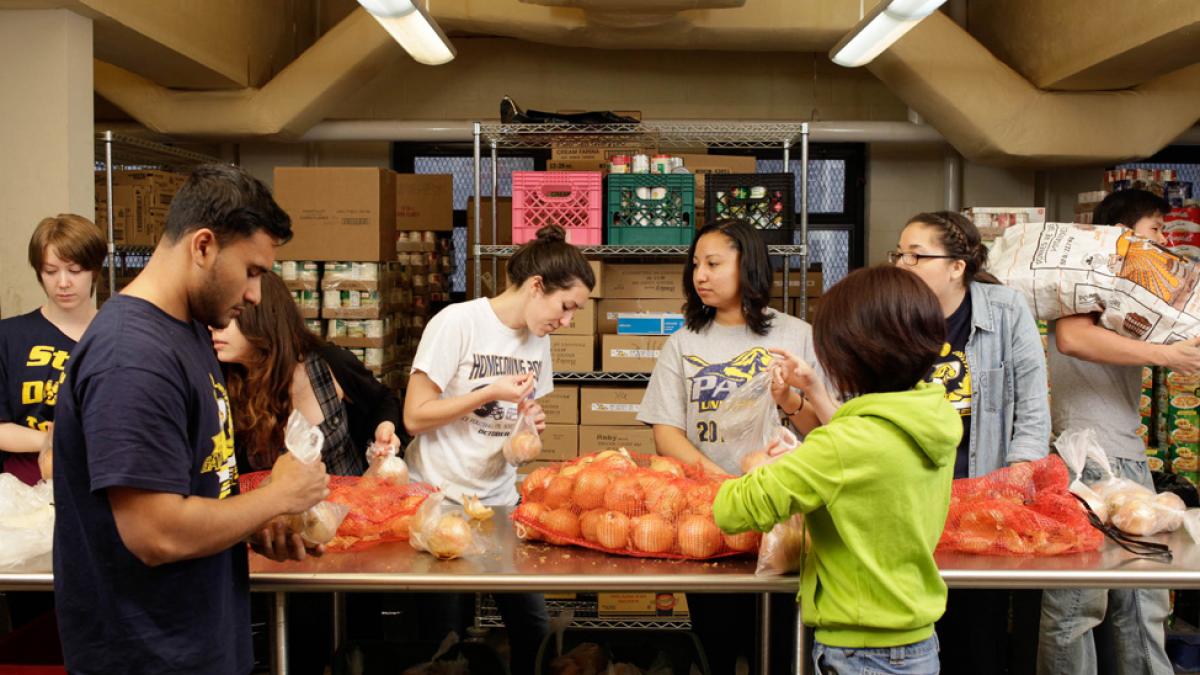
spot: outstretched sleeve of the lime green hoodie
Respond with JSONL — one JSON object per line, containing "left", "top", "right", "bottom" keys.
{"left": 713, "top": 428, "right": 844, "bottom": 532}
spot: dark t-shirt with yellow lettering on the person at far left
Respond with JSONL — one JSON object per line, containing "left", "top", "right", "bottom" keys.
{"left": 0, "top": 309, "right": 74, "bottom": 485}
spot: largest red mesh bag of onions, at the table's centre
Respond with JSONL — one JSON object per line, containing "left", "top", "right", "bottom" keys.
{"left": 512, "top": 448, "right": 761, "bottom": 560}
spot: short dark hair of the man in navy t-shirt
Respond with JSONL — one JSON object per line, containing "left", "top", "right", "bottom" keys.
{"left": 163, "top": 165, "right": 292, "bottom": 244}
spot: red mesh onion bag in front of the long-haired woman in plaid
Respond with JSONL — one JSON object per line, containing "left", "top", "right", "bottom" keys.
{"left": 240, "top": 471, "right": 437, "bottom": 551}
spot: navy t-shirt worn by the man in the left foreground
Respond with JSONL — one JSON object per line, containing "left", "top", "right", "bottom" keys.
{"left": 54, "top": 295, "right": 252, "bottom": 674}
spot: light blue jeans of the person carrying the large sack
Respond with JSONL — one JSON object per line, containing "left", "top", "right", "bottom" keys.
{"left": 1038, "top": 458, "right": 1174, "bottom": 675}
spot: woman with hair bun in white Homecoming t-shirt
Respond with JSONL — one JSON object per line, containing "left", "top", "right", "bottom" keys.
{"left": 404, "top": 226, "right": 595, "bottom": 673}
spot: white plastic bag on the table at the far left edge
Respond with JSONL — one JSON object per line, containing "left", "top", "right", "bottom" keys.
{"left": 0, "top": 473, "right": 54, "bottom": 572}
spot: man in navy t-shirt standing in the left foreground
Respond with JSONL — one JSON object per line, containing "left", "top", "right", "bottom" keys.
{"left": 54, "top": 165, "right": 329, "bottom": 674}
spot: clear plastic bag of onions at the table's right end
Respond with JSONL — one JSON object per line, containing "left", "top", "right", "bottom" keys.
{"left": 1055, "top": 429, "right": 1190, "bottom": 537}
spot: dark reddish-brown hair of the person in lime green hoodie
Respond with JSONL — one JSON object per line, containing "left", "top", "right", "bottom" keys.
{"left": 812, "top": 265, "right": 946, "bottom": 396}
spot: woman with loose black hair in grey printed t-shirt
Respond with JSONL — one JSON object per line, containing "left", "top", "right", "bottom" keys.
{"left": 637, "top": 220, "right": 832, "bottom": 673}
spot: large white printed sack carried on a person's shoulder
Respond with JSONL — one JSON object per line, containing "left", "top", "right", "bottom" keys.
{"left": 988, "top": 222, "right": 1200, "bottom": 345}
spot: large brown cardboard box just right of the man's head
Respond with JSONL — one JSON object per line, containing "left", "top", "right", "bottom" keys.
{"left": 275, "top": 167, "right": 396, "bottom": 262}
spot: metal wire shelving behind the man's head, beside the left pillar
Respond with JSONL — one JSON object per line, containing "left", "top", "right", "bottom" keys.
{"left": 95, "top": 131, "right": 221, "bottom": 295}
